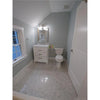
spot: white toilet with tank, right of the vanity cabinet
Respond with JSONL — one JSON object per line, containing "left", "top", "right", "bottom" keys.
{"left": 55, "top": 48, "right": 63, "bottom": 68}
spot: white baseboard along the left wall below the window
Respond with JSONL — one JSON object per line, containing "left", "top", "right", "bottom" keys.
{"left": 13, "top": 60, "right": 33, "bottom": 85}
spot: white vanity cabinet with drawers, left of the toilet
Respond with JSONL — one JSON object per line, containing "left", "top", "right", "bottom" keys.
{"left": 33, "top": 45, "right": 49, "bottom": 63}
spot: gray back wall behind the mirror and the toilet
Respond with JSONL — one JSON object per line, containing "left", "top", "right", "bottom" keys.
{"left": 40, "top": 12, "right": 70, "bottom": 58}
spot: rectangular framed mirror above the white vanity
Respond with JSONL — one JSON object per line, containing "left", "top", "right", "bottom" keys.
{"left": 38, "top": 27, "right": 49, "bottom": 44}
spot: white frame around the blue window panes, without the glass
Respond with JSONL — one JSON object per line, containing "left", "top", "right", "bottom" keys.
{"left": 13, "top": 25, "right": 27, "bottom": 66}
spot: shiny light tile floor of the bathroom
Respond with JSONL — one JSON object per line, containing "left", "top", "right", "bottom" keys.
{"left": 14, "top": 60, "right": 77, "bottom": 100}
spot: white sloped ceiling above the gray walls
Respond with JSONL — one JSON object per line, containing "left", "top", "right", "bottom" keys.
{"left": 13, "top": 0, "right": 79, "bottom": 27}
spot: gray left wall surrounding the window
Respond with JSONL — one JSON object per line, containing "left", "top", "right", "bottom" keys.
{"left": 13, "top": 18, "right": 36, "bottom": 76}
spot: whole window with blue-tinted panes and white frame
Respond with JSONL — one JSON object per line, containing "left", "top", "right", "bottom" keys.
{"left": 12, "top": 25, "right": 26, "bottom": 64}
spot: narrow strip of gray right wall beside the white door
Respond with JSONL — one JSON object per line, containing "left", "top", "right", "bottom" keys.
{"left": 67, "top": 2, "right": 80, "bottom": 65}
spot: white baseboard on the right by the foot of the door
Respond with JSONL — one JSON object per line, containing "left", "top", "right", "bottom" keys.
{"left": 68, "top": 69, "right": 80, "bottom": 94}
